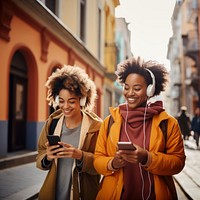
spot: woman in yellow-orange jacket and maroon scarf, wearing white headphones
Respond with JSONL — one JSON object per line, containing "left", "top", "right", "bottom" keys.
{"left": 94, "top": 57, "right": 185, "bottom": 200}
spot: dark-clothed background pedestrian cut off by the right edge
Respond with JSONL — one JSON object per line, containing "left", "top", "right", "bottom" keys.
{"left": 191, "top": 107, "right": 200, "bottom": 149}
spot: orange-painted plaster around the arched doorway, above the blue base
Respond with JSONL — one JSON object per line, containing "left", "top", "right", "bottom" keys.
{"left": 0, "top": 16, "right": 101, "bottom": 121}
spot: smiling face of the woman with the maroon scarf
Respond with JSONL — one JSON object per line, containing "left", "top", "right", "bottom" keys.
{"left": 123, "top": 73, "right": 147, "bottom": 108}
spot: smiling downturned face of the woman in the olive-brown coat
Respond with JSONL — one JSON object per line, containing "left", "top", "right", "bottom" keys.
{"left": 59, "top": 89, "right": 81, "bottom": 118}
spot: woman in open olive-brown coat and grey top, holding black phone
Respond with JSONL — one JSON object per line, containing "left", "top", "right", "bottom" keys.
{"left": 36, "top": 66, "right": 102, "bottom": 200}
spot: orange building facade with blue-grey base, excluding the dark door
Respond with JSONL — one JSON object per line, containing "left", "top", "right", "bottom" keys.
{"left": 0, "top": 1, "right": 104, "bottom": 157}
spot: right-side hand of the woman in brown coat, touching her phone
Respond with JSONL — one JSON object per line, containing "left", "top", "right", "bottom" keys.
{"left": 56, "top": 142, "right": 83, "bottom": 160}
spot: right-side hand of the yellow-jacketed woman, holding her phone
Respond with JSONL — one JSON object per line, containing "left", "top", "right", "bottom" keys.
{"left": 117, "top": 144, "right": 148, "bottom": 165}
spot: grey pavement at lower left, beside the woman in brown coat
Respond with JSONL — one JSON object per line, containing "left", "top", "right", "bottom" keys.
{"left": 0, "top": 162, "right": 47, "bottom": 200}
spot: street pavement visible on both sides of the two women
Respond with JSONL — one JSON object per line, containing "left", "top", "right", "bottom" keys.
{"left": 0, "top": 140, "right": 200, "bottom": 200}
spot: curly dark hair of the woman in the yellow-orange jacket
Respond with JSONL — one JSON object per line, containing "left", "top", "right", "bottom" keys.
{"left": 115, "top": 57, "right": 168, "bottom": 96}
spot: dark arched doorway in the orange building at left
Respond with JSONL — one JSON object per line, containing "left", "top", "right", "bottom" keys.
{"left": 8, "top": 51, "right": 28, "bottom": 152}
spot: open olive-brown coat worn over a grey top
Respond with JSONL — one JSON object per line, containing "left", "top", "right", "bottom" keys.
{"left": 36, "top": 110, "right": 101, "bottom": 200}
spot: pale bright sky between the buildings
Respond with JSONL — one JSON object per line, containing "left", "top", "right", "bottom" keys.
{"left": 115, "top": 0, "right": 176, "bottom": 69}
